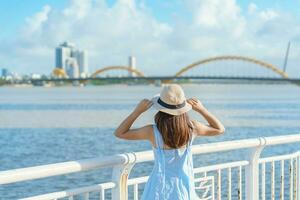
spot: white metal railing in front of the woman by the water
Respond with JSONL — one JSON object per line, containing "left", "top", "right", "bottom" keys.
{"left": 0, "top": 134, "right": 300, "bottom": 200}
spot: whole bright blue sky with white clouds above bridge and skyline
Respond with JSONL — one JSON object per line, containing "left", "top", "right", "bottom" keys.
{"left": 0, "top": 0, "right": 300, "bottom": 76}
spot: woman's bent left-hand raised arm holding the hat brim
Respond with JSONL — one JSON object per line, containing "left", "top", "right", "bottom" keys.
{"left": 114, "top": 99, "right": 153, "bottom": 140}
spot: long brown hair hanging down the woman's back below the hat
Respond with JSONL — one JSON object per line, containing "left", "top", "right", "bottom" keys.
{"left": 154, "top": 111, "right": 193, "bottom": 149}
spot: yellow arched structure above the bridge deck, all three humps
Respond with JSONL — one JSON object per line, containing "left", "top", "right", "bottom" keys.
{"left": 53, "top": 55, "right": 289, "bottom": 79}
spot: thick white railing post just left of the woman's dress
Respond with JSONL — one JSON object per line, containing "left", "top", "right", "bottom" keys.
{"left": 112, "top": 153, "right": 135, "bottom": 200}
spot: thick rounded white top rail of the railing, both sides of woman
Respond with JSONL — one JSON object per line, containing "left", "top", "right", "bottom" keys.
{"left": 0, "top": 134, "right": 300, "bottom": 185}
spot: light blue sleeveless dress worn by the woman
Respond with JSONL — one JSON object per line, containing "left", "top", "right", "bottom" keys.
{"left": 141, "top": 124, "right": 199, "bottom": 200}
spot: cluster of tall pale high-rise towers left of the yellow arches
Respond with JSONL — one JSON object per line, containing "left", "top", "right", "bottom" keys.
{"left": 55, "top": 42, "right": 89, "bottom": 78}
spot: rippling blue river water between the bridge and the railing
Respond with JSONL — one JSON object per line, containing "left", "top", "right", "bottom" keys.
{"left": 0, "top": 84, "right": 300, "bottom": 199}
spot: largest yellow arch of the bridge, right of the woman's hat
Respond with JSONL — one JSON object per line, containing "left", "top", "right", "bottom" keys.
{"left": 175, "top": 56, "right": 288, "bottom": 78}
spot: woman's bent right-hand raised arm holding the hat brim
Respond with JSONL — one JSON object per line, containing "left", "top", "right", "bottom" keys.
{"left": 187, "top": 98, "right": 225, "bottom": 136}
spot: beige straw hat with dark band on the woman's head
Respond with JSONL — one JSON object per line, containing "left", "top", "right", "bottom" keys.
{"left": 151, "top": 84, "right": 192, "bottom": 115}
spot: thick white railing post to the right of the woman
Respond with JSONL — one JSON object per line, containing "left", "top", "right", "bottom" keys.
{"left": 245, "top": 138, "right": 266, "bottom": 200}
